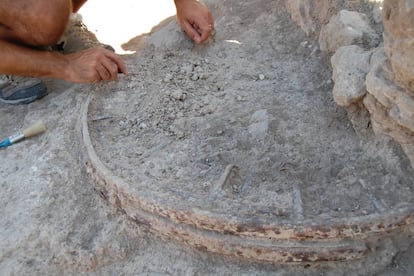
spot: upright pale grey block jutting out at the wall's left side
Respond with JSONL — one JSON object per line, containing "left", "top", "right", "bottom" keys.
{"left": 331, "top": 45, "right": 372, "bottom": 107}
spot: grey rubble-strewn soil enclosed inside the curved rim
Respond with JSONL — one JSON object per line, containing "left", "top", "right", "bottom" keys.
{"left": 90, "top": 2, "right": 414, "bottom": 223}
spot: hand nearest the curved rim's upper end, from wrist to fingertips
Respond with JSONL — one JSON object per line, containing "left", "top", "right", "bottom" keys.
{"left": 64, "top": 48, "right": 127, "bottom": 83}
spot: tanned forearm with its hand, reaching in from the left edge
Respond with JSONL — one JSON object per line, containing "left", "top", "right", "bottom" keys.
{"left": 0, "top": 40, "right": 126, "bottom": 83}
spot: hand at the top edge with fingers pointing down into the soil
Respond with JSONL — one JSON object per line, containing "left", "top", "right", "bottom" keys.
{"left": 174, "top": 0, "right": 214, "bottom": 43}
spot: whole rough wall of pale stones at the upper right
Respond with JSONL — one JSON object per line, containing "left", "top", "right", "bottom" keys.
{"left": 285, "top": 0, "right": 414, "bottom": 166}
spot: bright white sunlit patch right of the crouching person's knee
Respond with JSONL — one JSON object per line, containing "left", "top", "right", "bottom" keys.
{"left": 79, "top": 0, "right": 175, "bottom": 54}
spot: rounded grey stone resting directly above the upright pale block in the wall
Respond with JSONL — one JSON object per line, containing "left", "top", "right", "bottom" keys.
{"left": 319, "top": 10, "right": 380, "bottom": 53}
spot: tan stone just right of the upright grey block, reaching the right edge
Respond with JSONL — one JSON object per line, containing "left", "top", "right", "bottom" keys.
{"left": 366, "top": 48, "right": 414, "bottom": 132}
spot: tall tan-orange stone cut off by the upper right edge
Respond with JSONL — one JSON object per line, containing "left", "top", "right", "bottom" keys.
{"left": 383, "top": 0, "right": 414, "bottom": 93}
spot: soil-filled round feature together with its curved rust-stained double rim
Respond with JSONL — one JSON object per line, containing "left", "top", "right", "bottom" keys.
{"left": 82, "top": 1, "right": 414, "bottom": 262}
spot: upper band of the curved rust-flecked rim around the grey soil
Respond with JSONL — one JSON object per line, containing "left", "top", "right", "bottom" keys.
{"left": 81, "top": 95, "right": 414, "bottom": 243}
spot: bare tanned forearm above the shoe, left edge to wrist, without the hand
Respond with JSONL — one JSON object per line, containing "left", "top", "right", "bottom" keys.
{"left": 0, "top": 41, "right": 67, "bottom": 79}
